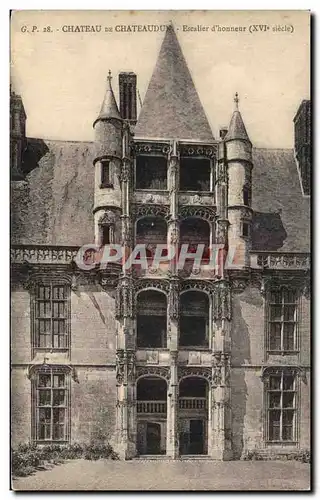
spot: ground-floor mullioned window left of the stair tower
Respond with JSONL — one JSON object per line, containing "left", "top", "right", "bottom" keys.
{"left": 32, "top": 366, "right": 70, "bottom": 442}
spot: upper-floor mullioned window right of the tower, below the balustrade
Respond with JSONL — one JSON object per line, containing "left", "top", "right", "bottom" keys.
{"left": 268, "top": 287, "right": 298, "bottom": 352}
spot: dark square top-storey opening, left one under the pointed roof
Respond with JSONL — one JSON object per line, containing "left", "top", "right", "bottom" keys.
{"left": 136, "top": 155, "right": 167, "bottom": 189}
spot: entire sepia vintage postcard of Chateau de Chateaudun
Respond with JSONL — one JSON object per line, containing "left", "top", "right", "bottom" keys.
{"left": 10, "top": 10, "right": 311, "bottom": 491}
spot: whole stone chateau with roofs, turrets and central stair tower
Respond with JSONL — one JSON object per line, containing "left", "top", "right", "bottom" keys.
{"left": 11, "top": 27, "right": 311, "bottom": 460}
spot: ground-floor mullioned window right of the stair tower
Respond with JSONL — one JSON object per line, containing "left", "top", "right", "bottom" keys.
{"left": 265, "top": 371, "right": 297, "bottom": 442}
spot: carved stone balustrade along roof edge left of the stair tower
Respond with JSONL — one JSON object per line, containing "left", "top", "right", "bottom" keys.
{"left": 10, "top": 245, "right": 79, "bottom": 264}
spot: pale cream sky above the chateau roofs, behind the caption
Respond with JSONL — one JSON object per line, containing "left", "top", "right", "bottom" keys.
{"left": 11, "top": 11, "right": 310, "bottom": 148}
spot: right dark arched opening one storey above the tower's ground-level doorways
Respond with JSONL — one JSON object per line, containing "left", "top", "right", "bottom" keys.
{"left": 180, "top": 290, "right": 209, "bottom": 347}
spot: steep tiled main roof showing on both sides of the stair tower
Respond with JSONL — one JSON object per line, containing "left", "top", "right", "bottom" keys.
{"left": 11, "top": 139, "right": 310, "bottom": 252}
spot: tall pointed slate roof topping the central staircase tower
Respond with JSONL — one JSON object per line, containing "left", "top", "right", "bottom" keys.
{"left": 135, "top": 26, "right": 213, "bottom": 142}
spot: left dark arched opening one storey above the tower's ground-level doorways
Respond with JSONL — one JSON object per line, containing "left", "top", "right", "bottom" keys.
{"left": 137, "top": 290, "right": 167, "bottom": 348}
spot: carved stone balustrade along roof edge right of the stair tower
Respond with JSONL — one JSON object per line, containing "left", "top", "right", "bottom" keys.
{"left": 251, "top": 252, "right": 310, "bottom": 270}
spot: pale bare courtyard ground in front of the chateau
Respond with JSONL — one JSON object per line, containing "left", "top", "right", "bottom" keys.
{"left": 12, "top": 460, "right": 310, "bottom": 491}
